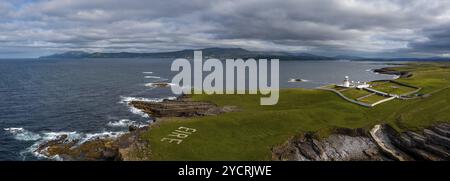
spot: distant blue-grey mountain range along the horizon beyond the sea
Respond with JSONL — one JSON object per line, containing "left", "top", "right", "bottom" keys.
{"left": 39, "top": 48, "right": 450, "bottom": 61}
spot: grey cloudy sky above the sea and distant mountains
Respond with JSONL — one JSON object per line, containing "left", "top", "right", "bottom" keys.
{"left": 0, "top": 0, "right": 450, "bottom": 58}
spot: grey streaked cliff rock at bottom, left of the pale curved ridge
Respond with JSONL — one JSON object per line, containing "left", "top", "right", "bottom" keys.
{"left": 272, "top": 129, "right": 389, "bottom": 161}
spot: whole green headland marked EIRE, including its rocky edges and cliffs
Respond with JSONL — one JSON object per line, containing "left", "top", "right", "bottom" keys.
{"left": 36, "top": 63, "right": 450, "bottom": 160}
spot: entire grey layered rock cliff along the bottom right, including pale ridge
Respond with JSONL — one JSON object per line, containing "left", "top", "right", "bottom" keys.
{"left": 272, "top": 124, "right": 450, "bottom": 161}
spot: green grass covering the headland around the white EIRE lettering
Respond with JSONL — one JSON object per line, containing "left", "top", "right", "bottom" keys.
{"left": 143, "top": 61, "right": 450, "bottom": 160}
